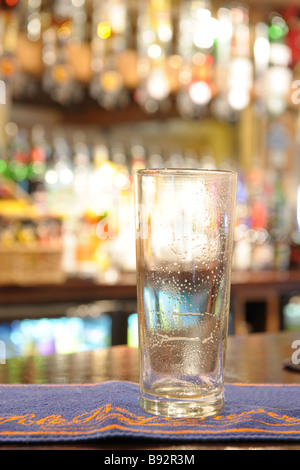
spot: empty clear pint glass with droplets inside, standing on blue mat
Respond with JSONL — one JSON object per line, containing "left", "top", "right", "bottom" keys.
{"left": 134, "top": 169, "right": 237, "bottom": 417}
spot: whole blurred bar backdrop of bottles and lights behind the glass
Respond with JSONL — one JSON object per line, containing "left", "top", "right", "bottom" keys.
{"left": 0, "top": 0, "right": 300, "bottom": 355}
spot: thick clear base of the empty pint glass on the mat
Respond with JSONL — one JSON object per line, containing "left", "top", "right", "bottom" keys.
{"left": 140, "top": 394, "right": 224, "bottom": 418}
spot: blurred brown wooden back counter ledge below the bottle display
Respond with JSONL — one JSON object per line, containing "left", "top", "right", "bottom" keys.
{"left": 0, "top": 270, "right": 300, "bottom": 336}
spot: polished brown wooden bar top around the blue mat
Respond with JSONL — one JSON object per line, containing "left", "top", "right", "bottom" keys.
{"left": 0, "top": 331, "right": 300, "bottom": 451}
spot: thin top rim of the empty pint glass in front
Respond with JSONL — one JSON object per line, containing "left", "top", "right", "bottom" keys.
{"left": 133, "top": 168, "right": 237, "bottom": 176}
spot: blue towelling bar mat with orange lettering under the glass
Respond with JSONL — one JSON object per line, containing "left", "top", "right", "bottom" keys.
{"left": 0, "top": 381, "right": 300, "bottom": 442}
